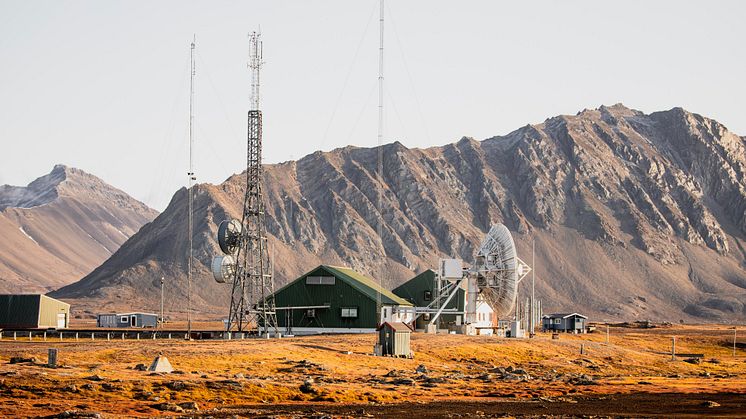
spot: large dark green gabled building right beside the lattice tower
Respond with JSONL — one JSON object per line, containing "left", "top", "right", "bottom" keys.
{"left": 275, "top": 265, "right": 412, "bottom": 334}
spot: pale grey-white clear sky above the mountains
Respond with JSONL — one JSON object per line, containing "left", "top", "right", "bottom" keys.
{"left": 0, "top": 0, "right": 746, "bottom": 210}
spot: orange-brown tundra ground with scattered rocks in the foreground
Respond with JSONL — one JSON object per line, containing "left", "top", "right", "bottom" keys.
{"left": 0, "top": 325, "right": 746, "bottom": 417}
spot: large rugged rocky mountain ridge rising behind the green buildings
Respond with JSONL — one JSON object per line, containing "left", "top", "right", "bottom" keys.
{"left": 54, "top": 105, "right": 746, "bottom": 322}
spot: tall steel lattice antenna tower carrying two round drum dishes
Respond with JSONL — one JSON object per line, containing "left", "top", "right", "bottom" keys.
{"left": 228, "top": 32, "right": 278, "bottom": 336}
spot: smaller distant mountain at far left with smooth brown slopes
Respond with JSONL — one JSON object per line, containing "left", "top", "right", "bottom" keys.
{"left": 0, "top": 165, "right": 158, "bottom": 293}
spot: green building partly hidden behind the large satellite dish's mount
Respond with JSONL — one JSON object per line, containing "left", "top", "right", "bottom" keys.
{"left": 393, "top": 269, "right": 466, "bottom": 330}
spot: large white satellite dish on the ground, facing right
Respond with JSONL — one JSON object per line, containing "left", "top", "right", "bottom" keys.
{"left": 473, "top": 224, "right": 531, "bottom": 317}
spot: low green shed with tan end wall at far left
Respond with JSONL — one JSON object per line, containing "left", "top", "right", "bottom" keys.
{"left": 0, "top": 294, "right": 70, "bottom": 329}
